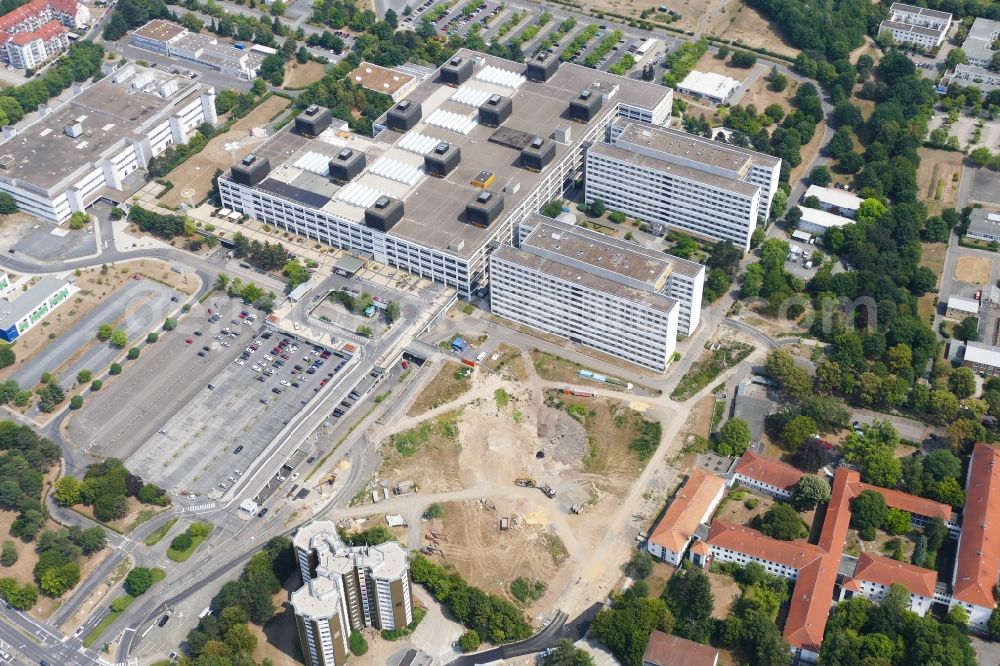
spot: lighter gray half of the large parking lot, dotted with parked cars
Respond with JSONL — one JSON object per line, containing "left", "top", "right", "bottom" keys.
{"left": 121, "top": 313, "right": 358, "bottom": 499}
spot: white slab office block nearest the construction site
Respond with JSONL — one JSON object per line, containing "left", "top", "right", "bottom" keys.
{"left": 490, "top": 216, "right": 705, "bottom": 371}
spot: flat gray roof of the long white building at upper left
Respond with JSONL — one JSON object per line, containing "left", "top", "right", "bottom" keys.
{"left": 0, "top": 64, "right": 207, "bottom": 192}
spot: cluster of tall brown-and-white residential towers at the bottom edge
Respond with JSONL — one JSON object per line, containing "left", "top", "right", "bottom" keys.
{"left": 292, "top": 521, "right": 413, "bottom": 666}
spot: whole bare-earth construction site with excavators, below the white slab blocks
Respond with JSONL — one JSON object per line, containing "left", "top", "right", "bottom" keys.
{"left": 342, "top": 348, "right": 676, "bottom": 616}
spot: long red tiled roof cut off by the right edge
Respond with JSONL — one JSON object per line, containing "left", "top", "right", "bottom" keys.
{"left": 952, "top": 443, "right": 1000, "bottom": 608}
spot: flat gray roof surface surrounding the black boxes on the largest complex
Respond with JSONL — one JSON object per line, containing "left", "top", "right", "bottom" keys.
{"left": 223, "top": 49, "right": 670, "bottom": 257}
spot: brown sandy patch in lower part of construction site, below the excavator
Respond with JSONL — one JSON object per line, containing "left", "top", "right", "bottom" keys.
{"left": 433, "top": 495, "right": 566, "bottom": 606}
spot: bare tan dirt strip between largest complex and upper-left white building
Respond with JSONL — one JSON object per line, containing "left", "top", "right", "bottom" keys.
{"left": 160, "top": 95, "right": 291, "bottom": 208}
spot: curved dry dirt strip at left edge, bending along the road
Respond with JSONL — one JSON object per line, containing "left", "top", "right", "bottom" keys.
{"left": 0, "top": 259, "right": 198, "bottom": 381}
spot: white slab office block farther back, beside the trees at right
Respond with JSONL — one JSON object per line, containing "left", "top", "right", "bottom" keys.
{"left": 585, "top": 123, "right": 781, "bottom": 252}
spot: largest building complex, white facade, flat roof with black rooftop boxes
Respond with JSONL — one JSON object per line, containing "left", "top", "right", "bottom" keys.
{"left": 219, "top": 50, "right": 672, "bottom": 295}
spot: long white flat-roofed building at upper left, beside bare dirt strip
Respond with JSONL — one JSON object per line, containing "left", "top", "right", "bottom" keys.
{"left": 0, "top": 64, "right": 218, "bottom": 224}
